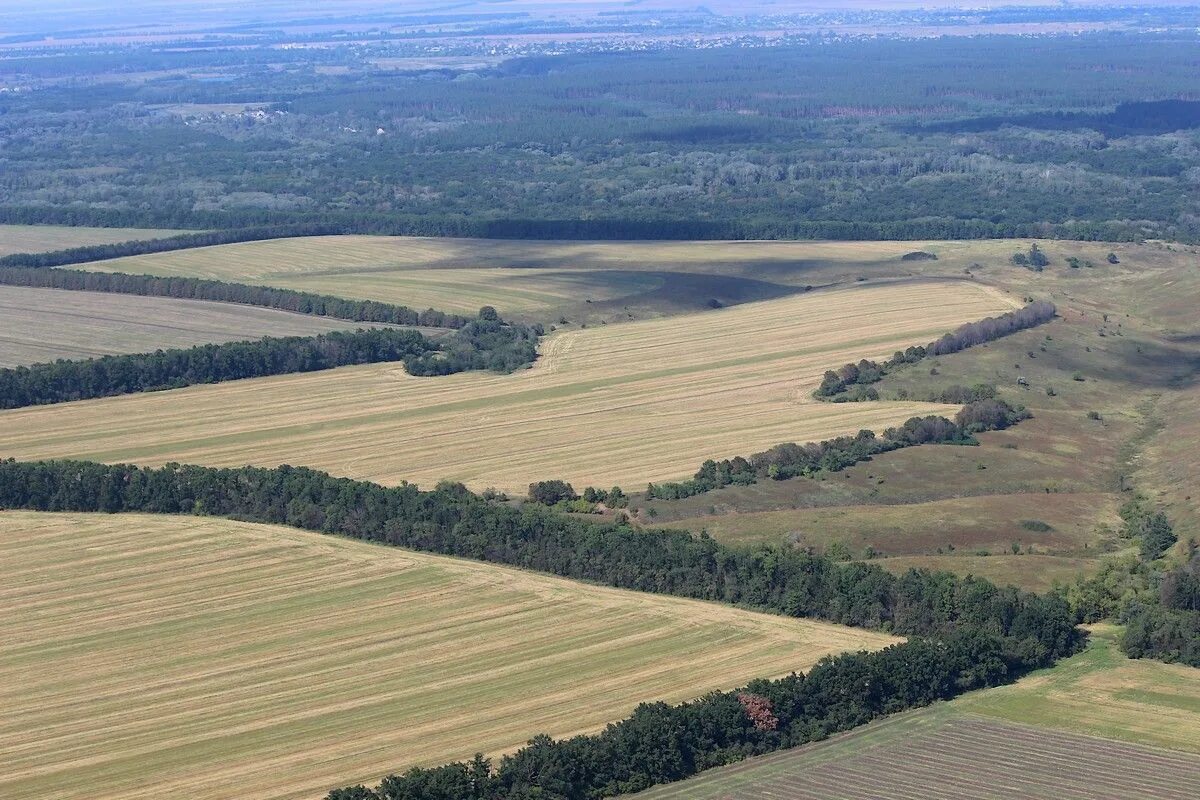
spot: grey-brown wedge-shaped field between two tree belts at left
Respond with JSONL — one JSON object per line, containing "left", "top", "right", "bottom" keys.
{"left": 0, "top": 285, "right": 398, "bottom": 367}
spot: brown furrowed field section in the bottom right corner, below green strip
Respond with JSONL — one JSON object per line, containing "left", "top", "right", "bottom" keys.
{"left": 635, "top": 705, "right": 1200, "bottom": 800}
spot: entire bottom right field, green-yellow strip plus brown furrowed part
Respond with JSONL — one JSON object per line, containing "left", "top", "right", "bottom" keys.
{"left": 637, "top": 625, "right": 1200, "bottom": 800}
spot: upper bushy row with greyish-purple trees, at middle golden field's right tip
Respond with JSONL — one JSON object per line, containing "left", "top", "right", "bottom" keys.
{"left": 814, "top": 300, "right": 1057, "bottom": 403}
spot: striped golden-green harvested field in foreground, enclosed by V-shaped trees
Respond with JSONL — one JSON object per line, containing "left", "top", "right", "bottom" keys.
{"left": 0, "top": 512, "right": 894, "bottom": 800}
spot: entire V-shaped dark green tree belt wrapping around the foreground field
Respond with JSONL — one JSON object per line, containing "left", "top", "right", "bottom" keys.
{"left": 0, "top": 459, "right": 1081, "bottom": 800}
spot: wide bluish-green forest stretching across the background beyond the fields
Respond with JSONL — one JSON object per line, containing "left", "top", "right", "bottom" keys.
{"left": 0, "top": 31, "right": 1200, "bottom": 241}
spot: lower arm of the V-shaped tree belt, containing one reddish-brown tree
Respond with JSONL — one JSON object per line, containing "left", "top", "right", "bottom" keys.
{"left": 325, "top": 626, "right": 1069, "bottom": 800}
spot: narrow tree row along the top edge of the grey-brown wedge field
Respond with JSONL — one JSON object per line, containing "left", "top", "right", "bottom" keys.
{"left": 0, "top": 266, "right": 469, "bottom": 329}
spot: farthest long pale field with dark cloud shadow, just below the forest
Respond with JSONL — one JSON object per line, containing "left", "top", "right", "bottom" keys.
{"left": 83, "top": 236, "right": 1156, "bottom": 325}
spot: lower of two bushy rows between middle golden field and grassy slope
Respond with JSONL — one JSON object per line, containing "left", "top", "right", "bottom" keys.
{"left": 646, "top": 398, "right": 1030, "bottom": 500}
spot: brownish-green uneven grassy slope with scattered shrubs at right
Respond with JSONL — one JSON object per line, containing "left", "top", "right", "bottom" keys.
{"left": 653, "top": 237, "right": 1200, "bottom": 589}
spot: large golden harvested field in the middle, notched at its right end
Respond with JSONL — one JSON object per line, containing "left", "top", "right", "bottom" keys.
{"left": 0, "top": 283, "right": 1012, "bottom": 492}
